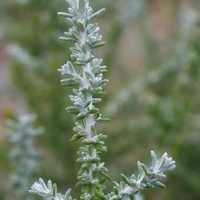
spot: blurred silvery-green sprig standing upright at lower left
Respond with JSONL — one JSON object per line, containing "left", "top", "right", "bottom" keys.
{"left": 7, "top": 114, "right": 43, "bottom": 200}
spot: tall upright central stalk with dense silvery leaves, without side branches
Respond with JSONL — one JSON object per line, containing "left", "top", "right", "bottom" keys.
{"left": 58, "top": 0, "right": 108, "bottom": 199}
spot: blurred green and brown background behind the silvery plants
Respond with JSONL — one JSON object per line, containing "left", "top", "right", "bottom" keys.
{"left": 0, "top": 0, "right": 200, "bottom": 200}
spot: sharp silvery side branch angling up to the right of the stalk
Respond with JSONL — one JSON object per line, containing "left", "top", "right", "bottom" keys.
{"left": 108, "top": 151, "right": 176, "bottom": 200}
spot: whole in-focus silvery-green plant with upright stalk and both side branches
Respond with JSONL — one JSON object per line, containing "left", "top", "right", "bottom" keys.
{"left": 29, "top": 0, "right": 175, "bottom": 200}
